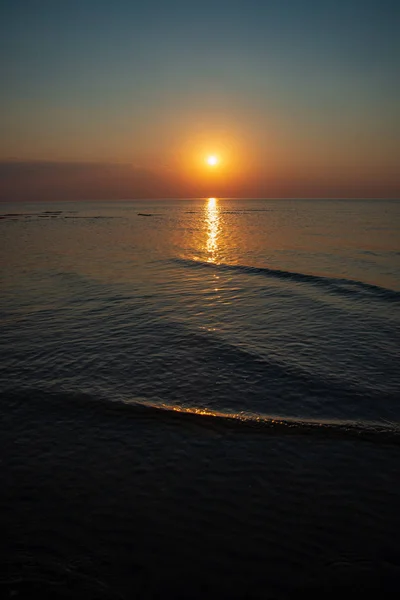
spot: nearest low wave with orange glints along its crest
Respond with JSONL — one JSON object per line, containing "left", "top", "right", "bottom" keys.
{"left": 1, "top": 389, "right": 400, "bottom": 446}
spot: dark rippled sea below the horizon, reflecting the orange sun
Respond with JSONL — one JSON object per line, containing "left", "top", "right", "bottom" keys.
{"left": 0, "top": 198, "right": 400, "bottom": 599}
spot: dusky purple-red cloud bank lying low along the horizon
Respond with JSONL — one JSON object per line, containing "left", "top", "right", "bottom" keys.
{"left": 0, "top": 160, "right": 400, "bottom": 202}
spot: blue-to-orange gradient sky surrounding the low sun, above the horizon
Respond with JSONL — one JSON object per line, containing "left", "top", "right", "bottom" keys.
{"left": 0, "top": 0, "right": 400, "bottom": 200}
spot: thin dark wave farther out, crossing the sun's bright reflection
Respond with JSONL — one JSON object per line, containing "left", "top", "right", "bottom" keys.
{"left": 171, "top": 258, "right": 400, "bottom": 302}
